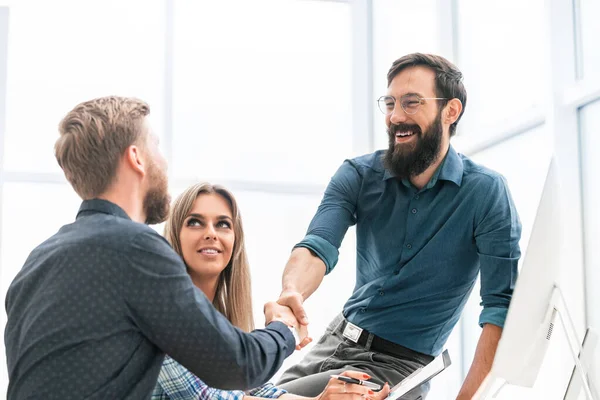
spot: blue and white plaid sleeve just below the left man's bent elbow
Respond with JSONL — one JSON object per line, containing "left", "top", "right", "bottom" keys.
{"left": 152, "top": 356, "right": 244, "bottom": 400}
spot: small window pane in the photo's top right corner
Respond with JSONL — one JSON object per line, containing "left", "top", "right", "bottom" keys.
{"left": 577, "top": 0, "right": 600, "bottom": 80}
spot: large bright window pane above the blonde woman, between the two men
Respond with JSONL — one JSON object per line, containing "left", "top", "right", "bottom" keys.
{"left": 172, "top": 0, "right": 352, "bottom": 183}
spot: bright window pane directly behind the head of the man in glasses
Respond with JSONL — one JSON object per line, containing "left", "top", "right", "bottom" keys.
{"left": 373, "top": 0, "right": 451, "bottom": 149}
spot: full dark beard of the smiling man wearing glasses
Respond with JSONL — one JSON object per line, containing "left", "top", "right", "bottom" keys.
{"left": 383, "top": 112, "right": 443, "bottom": 179}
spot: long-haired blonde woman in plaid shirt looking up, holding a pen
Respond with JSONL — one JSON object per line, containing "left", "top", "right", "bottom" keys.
{"left": 152, "top": 183, "right": 389, "bottom": 400}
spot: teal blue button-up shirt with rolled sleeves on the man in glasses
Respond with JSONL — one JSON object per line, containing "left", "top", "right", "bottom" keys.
{"left": 296, "top": 146, "right": 521, "bottom": 355}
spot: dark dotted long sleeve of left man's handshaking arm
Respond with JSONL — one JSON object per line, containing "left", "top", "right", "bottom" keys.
{"left": 120, "top": 232, "right": 295, "bottom": 390}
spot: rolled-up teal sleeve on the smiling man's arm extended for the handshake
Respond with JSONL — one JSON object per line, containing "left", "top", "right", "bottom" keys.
{"left": 294, "top": 160, "right": 362, "bottom": 274}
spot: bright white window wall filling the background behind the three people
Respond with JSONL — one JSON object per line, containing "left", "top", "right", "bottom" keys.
{"left": 0, "top": 0, "right": 600, "bottom": 400}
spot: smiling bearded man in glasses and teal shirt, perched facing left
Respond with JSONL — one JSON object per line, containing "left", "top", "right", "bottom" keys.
{"left": 278, "top": 53, "right": 521, "bottom": 399}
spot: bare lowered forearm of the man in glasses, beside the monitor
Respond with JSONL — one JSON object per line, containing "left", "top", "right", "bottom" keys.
{"left": 457, "top": 324, "right": 502, "bottom": 400}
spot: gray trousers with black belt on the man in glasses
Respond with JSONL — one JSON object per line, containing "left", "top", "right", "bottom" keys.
{"left": 277, "top": 314, "right": 429, "bottom": 400}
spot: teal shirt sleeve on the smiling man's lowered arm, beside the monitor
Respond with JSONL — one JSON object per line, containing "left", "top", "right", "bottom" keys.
{"left": 475, "top": 176, "right": 521, "bottom": 327}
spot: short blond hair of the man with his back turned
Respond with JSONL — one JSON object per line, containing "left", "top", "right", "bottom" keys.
{"left": 54, "top": 96, "right": 150, "bottom": 200}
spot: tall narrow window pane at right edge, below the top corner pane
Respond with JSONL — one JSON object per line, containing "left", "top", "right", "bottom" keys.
{"left": 579, "top": 101, "right": 600, "bottom": 332}
